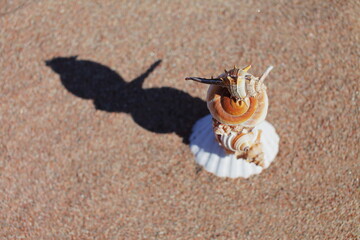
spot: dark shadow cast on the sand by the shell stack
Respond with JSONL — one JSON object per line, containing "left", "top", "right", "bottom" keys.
{"left": 45, "top": 57, "right": 208, "bottom": 144}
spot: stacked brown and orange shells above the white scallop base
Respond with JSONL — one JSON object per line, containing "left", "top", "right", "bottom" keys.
{"left": 186, "top": 65, "right": 276, "bottom": 167}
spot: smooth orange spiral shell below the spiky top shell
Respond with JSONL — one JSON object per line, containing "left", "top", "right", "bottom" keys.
{"left": 206, "top": 85, "right": 268, "bottom": 127}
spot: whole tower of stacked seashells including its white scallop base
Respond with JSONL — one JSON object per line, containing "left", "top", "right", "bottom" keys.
{"left": 186, "top": 66, "right": 279, "bottom": 177}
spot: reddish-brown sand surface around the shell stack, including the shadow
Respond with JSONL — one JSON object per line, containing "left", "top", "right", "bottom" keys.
{"left": 0, "top": 0, "right": 360, "bottom": 239}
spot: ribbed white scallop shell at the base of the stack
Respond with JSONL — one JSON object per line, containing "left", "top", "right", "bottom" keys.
{"left": 190, "top": 114, "right": 280, "bottom": 178}
